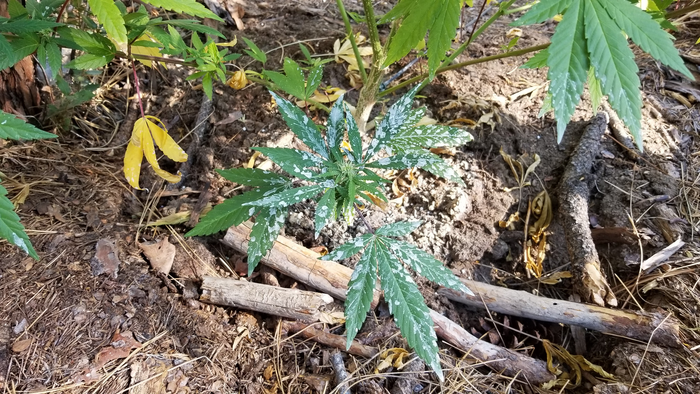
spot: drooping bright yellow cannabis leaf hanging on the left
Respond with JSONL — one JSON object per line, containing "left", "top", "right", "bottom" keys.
{"left": 124, "top": 116, "right": 187, "bottom": 190}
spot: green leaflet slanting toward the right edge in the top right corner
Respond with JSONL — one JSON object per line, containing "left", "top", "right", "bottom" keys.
{"left": 599, "top": 0, "right": 695, "bottom": 80}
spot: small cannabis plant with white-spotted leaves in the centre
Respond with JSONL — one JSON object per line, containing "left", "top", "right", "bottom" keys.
{"left": 186, "top": 87, "right": 472, "bottom": 379}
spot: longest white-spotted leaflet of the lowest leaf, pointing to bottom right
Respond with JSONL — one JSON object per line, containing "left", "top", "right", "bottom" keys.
{"left": 373, "top": 240, "right": 444, "bottom": 380}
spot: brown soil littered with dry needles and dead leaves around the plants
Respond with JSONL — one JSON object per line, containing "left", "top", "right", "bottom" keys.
{"left": 0, "top": 0, "right": 700, "bottom": 393}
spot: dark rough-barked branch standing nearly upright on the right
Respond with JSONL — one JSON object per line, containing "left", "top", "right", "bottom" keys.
{"left": 559, "top": 113, "right": 617, "bottom": 306}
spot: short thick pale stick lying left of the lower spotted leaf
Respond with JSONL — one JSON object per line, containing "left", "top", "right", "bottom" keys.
{"left": 199, "top": 276, "right": 333, "bottom": 323}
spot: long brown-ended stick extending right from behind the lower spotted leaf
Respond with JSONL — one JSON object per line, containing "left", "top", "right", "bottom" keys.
{"left": 438, "top": 280, "right": 681, "bottom": 347}
